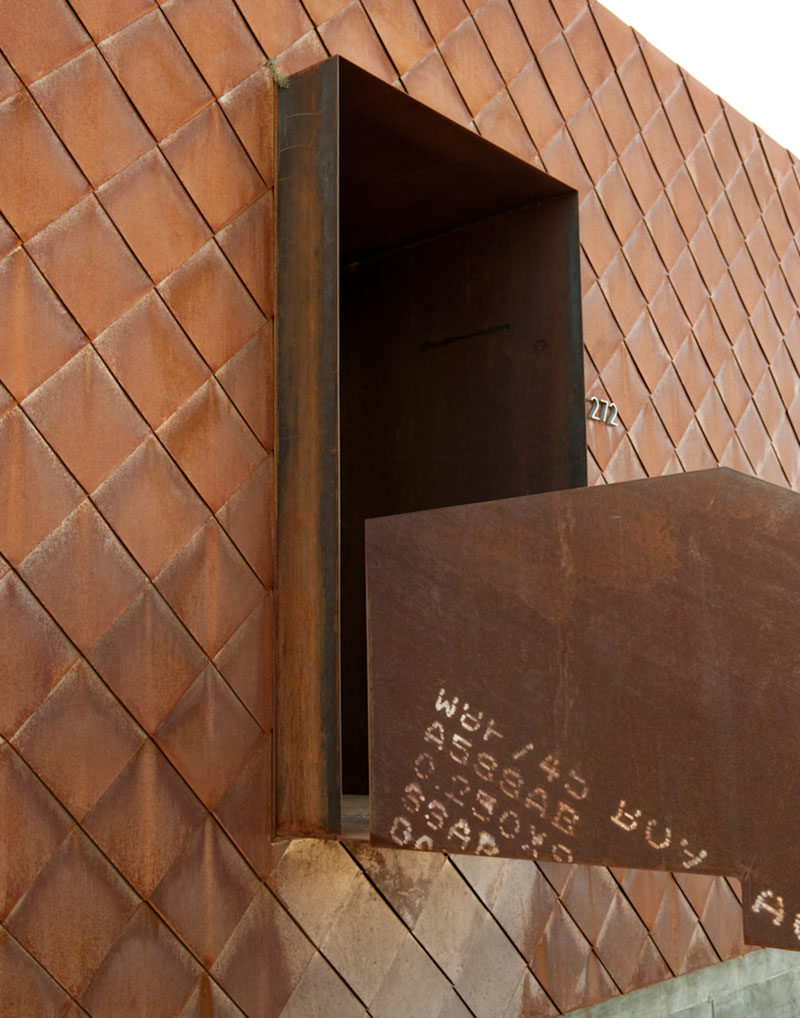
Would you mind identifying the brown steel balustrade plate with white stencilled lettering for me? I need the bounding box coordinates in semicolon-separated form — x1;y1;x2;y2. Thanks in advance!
366;469;800;948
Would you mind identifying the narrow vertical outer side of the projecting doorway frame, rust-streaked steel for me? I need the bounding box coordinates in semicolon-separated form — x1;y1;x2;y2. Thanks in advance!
276;61;341;834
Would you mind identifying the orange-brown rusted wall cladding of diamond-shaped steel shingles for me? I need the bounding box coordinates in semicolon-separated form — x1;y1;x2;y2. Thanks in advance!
0;0;800;1018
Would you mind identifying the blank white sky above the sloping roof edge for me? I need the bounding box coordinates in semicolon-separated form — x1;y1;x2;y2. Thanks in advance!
603;0;800;156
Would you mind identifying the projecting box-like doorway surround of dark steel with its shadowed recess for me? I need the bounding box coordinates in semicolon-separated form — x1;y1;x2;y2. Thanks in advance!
276;57;586;834
